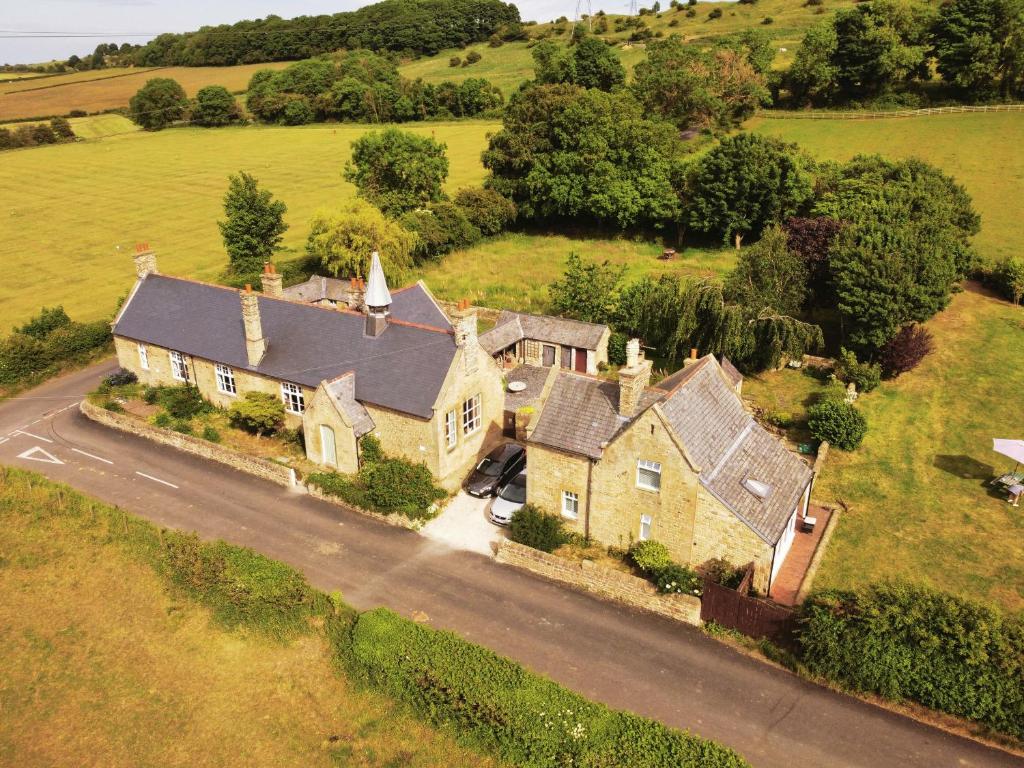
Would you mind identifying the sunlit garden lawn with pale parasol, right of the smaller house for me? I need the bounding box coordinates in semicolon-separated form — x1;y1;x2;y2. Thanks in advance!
798;288;1024;609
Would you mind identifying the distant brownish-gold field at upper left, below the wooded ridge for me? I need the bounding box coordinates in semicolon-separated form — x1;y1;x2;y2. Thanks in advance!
0;61;288;120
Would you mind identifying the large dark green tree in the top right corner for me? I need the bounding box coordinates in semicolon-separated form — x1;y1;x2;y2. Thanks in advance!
932;0;1024;98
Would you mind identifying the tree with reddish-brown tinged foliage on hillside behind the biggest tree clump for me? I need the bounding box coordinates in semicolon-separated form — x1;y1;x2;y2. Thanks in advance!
633;35;771;129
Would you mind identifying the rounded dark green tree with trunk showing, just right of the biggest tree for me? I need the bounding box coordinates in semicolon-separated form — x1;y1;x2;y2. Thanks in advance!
686;133;813;248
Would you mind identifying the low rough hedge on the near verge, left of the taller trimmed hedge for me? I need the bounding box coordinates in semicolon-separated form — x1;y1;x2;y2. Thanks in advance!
161;530;327;639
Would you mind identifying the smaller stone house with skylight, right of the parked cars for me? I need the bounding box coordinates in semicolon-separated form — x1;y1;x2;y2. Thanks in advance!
526;340;813;594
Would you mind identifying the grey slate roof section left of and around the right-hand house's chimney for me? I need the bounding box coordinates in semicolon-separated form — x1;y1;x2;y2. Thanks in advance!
529;372;665;459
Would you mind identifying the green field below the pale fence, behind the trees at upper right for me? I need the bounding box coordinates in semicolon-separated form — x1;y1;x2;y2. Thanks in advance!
748;111;1024;268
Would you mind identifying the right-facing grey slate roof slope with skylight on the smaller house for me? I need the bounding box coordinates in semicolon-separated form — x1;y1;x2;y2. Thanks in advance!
658;355;811;545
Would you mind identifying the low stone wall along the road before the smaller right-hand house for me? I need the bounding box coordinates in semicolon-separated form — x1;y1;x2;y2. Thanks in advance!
497;539;700;627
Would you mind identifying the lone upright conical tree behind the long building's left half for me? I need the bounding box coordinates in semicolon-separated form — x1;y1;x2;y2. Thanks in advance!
217;171;288;275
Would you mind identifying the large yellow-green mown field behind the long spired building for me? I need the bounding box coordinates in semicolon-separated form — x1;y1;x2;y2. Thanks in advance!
0;122;497;330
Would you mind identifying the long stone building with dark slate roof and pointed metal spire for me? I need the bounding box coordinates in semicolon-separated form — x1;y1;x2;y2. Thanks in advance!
113;251;504;490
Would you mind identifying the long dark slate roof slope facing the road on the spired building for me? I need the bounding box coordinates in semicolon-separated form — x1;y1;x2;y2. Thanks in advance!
114;274;456;419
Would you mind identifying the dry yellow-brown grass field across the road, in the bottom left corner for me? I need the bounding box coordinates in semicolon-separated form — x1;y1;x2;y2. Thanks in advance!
0;479;493;768
